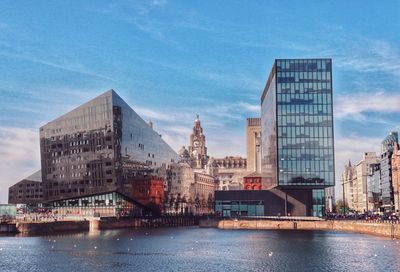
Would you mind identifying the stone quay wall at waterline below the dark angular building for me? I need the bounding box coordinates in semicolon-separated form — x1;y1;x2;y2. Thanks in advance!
16;216;199;235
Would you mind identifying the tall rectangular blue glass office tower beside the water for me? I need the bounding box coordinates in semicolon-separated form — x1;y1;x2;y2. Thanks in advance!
261;59;335;216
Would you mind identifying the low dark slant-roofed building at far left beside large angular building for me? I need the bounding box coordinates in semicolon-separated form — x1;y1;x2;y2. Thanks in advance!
8;170;44;206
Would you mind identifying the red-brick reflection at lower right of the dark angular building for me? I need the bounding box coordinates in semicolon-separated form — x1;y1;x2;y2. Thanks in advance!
132;175;165;211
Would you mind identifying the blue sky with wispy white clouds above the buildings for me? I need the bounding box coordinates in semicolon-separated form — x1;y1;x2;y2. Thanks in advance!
0;0;400;203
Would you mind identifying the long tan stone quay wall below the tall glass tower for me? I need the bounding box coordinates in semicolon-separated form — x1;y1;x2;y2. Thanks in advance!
199;219;400;238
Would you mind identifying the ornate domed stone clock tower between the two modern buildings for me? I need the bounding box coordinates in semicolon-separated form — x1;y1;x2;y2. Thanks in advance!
189;115;208;168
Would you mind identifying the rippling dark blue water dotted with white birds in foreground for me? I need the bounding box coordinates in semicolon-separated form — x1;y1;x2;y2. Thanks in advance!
0;227;400;272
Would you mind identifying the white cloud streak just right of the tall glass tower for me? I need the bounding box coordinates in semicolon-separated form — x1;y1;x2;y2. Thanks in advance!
334;91;400;120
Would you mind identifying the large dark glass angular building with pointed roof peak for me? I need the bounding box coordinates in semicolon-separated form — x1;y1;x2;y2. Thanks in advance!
40;90;179;215
